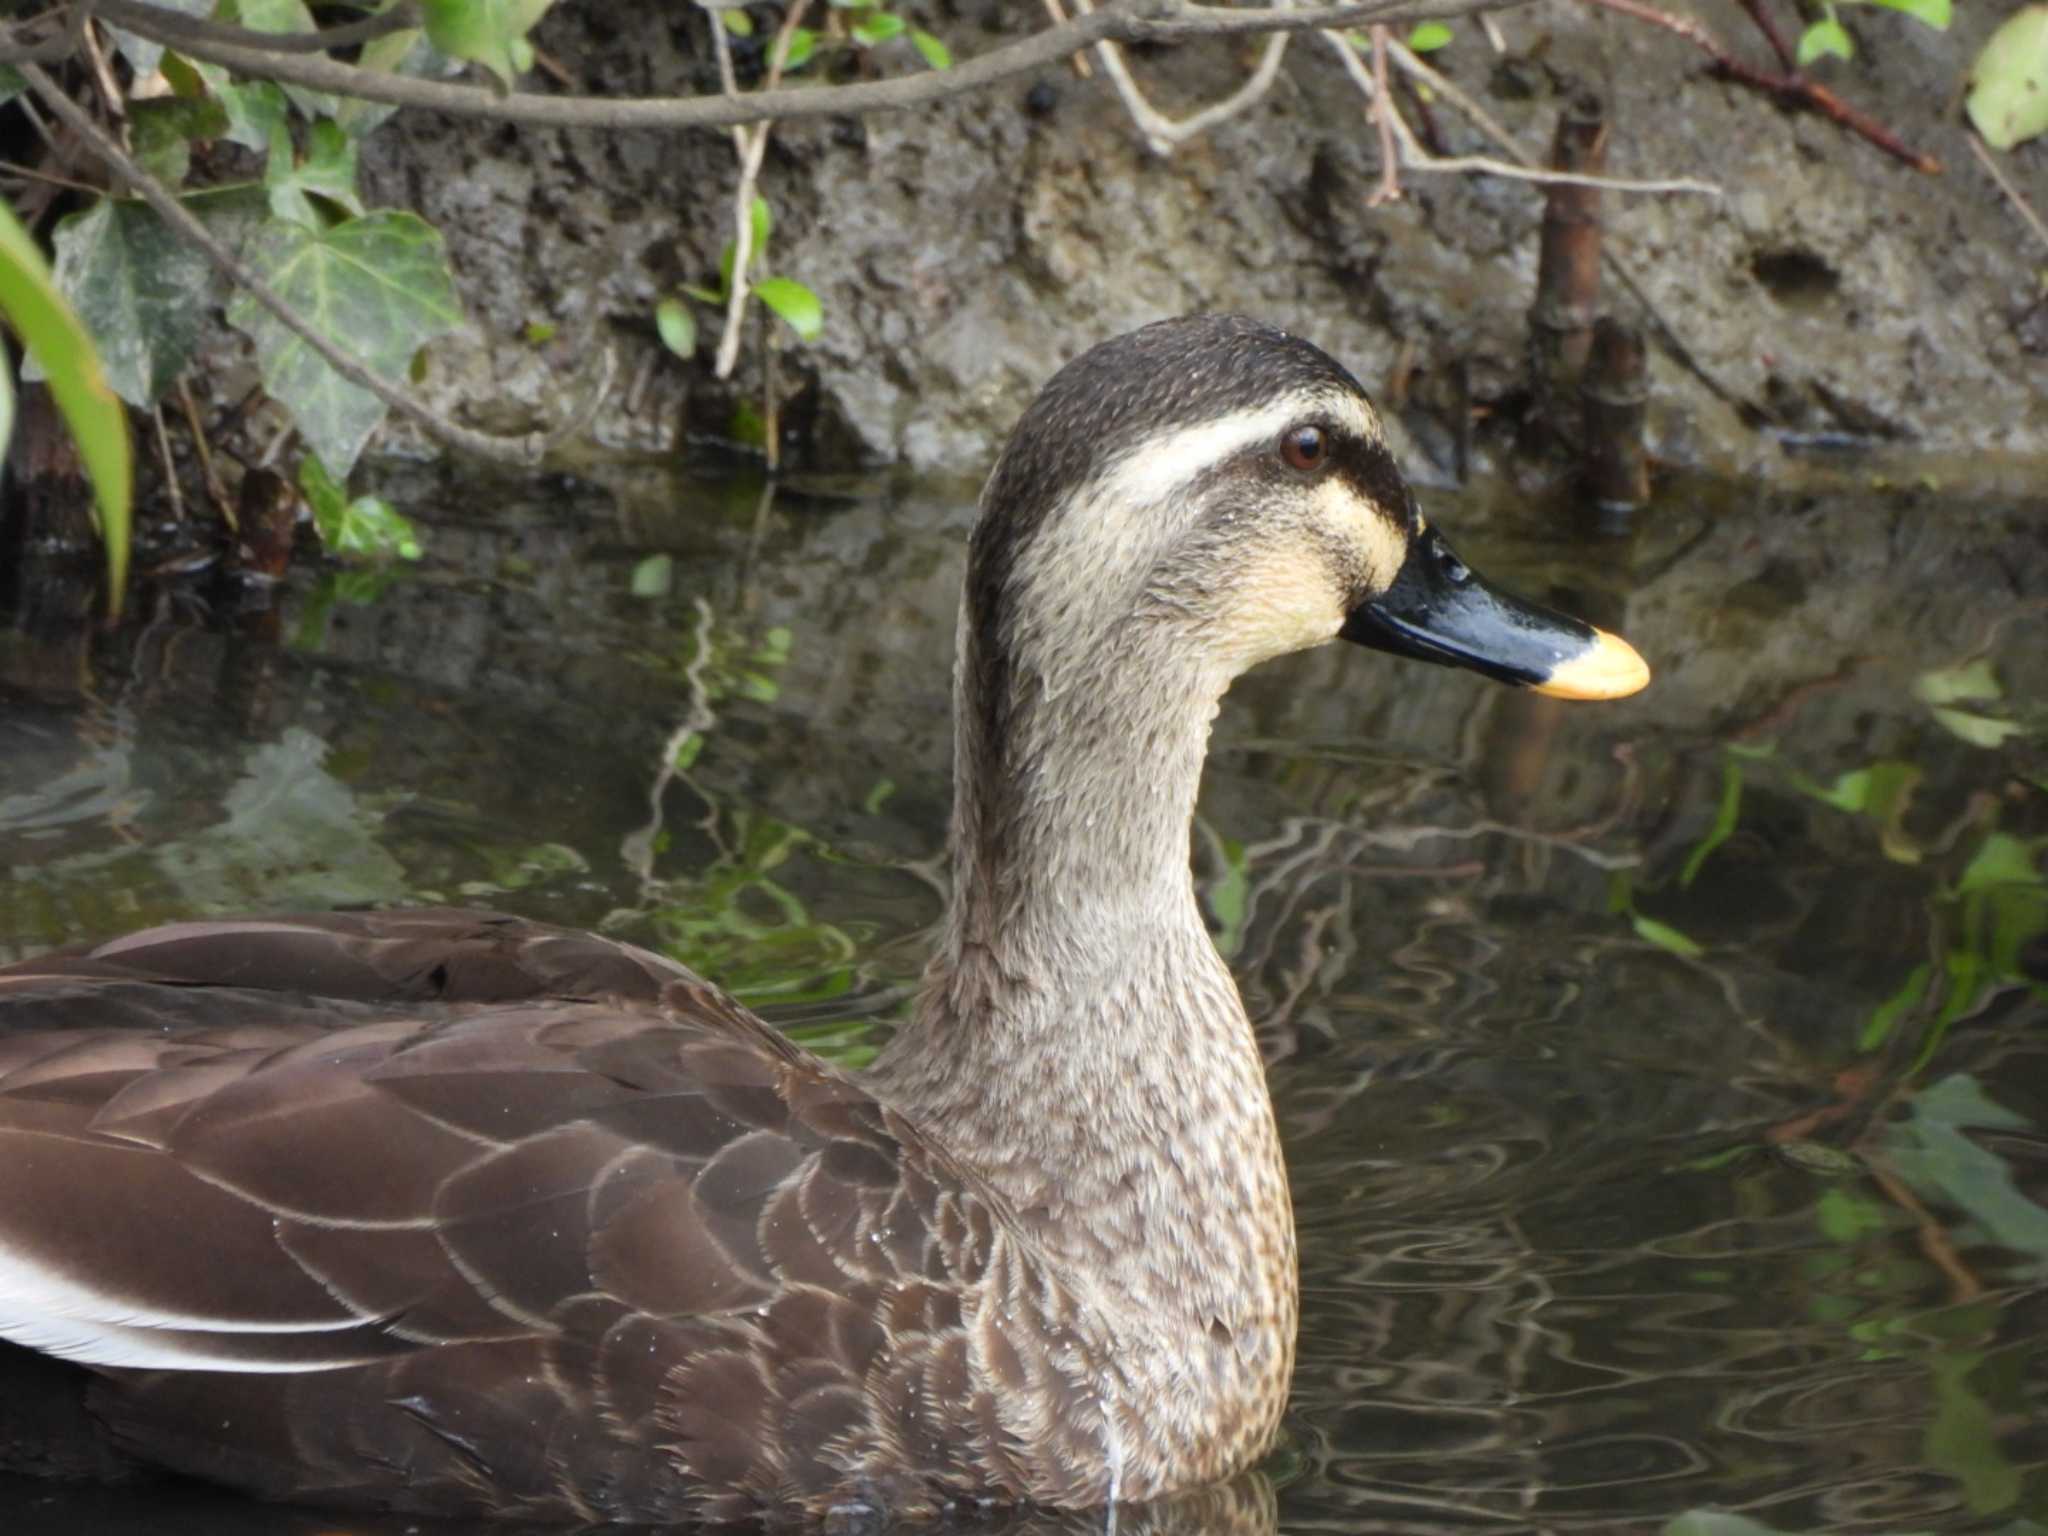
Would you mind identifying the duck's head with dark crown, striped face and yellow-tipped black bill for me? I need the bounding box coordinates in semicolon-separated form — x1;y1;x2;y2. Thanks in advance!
967;315;1649;711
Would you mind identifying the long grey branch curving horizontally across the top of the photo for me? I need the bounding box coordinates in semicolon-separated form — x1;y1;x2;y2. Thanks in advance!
96;0;1522;131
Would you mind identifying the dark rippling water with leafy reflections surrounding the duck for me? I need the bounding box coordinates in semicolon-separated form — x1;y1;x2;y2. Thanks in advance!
0;471;2048;1536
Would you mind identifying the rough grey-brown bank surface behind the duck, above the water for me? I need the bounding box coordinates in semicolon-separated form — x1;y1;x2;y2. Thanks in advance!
356;0;2048;475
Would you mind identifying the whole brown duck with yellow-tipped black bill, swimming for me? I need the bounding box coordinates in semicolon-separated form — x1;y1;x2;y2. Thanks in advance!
0;315;1649;1528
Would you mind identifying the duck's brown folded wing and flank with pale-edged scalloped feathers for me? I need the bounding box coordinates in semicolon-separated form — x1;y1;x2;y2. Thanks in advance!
0;913;1102;1520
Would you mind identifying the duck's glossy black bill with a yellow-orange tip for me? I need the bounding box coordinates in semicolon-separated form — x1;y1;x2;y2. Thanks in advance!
1341;528;1651;698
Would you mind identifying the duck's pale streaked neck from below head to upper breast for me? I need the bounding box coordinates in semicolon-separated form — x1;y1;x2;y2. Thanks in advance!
874;627;1294;1370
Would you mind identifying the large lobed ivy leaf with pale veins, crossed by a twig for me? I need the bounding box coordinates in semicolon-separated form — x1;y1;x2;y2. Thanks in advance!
227;209;463;475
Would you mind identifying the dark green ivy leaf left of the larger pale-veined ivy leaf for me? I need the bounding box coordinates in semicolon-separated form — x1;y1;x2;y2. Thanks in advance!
35;199;213;410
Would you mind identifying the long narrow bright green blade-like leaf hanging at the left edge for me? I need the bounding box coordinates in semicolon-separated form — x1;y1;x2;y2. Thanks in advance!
0;203;133;614
